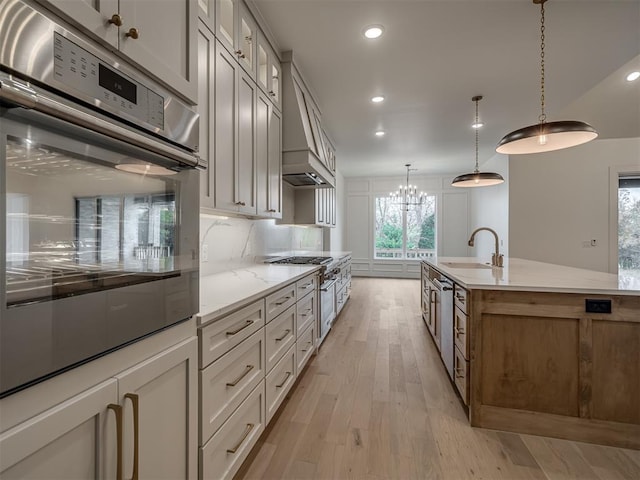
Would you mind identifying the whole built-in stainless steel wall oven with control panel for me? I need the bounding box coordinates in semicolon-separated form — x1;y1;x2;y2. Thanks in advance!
0;0;204;397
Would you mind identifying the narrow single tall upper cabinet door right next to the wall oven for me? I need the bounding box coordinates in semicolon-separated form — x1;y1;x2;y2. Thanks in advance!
198;22;216;208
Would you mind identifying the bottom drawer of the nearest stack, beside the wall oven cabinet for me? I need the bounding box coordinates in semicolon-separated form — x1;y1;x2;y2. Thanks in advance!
200;380;266;480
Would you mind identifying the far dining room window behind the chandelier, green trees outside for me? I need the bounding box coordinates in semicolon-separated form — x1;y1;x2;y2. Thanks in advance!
374;195;436;259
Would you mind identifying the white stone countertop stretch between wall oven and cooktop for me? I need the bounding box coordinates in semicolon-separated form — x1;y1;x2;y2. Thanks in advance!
197;263;320;326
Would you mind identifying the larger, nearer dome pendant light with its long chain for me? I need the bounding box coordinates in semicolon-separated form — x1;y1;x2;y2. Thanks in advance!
496;0;598;155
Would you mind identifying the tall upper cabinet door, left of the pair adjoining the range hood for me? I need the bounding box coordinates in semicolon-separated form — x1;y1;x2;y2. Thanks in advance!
256;93;271;217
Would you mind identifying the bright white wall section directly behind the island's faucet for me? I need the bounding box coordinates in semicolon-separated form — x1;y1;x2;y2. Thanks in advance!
469;154;509;258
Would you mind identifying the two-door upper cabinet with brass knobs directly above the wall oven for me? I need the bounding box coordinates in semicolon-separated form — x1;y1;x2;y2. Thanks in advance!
48;0;198;104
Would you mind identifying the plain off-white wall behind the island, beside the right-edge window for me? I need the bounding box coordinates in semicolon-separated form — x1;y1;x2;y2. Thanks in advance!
509;138;640;272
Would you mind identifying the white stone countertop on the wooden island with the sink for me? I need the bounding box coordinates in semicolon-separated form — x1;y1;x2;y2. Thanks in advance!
424;257;640;295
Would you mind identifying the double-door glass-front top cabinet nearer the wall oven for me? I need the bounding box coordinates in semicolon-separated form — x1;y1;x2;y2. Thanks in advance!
215;0;258;79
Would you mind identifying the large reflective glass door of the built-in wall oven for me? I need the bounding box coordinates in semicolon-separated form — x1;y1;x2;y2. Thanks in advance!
0;102;199;398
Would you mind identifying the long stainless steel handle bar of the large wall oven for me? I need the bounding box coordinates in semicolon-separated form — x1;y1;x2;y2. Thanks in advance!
0;76;207;169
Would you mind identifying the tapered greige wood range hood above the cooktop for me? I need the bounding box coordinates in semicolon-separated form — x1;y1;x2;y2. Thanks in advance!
282;51;336;188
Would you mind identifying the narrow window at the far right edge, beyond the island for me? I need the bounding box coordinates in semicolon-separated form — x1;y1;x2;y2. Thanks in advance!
618;175;640;288
